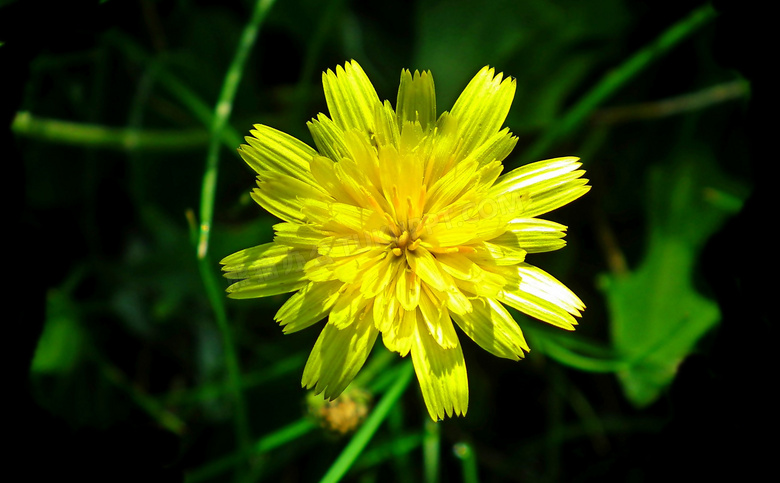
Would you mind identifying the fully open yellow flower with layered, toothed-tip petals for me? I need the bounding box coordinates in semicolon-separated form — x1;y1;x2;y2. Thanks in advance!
222;61;590;420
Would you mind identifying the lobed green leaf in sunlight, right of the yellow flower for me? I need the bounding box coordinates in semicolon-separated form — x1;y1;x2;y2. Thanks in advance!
604;151;744;407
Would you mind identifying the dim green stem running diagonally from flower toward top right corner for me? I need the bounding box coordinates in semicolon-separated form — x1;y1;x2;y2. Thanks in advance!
520;4;716;165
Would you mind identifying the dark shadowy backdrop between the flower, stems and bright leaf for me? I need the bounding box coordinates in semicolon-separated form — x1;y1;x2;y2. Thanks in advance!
6;0;777;481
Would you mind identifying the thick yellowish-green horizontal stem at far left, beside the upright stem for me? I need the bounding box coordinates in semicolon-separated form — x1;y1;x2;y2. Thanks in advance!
11;111;209;151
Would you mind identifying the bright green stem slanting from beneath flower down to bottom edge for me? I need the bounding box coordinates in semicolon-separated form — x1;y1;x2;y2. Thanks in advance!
320;361;414;483
